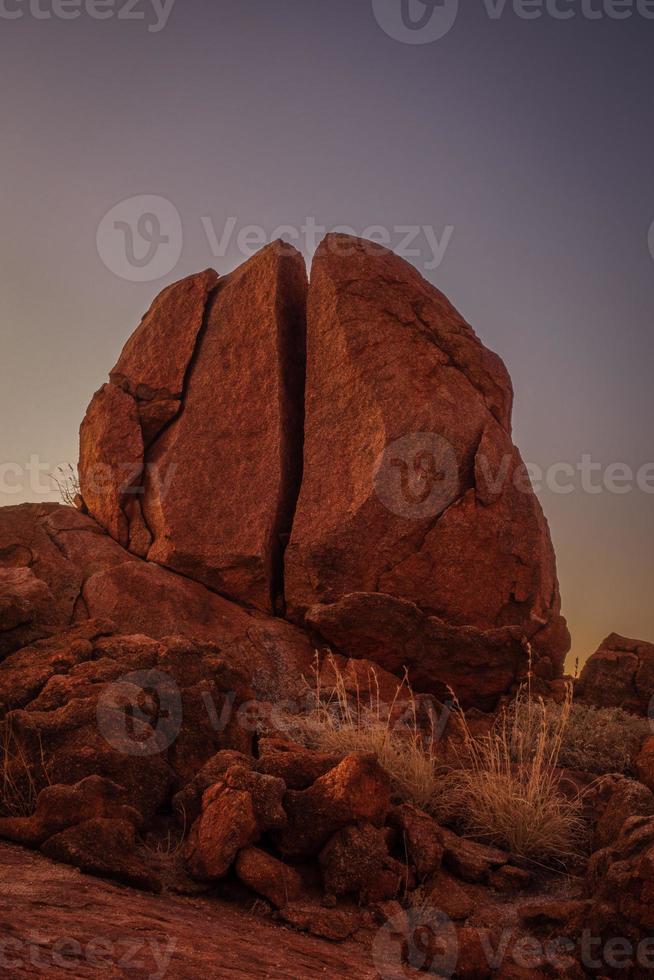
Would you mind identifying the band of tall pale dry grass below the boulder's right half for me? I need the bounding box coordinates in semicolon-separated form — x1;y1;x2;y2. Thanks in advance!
276;658;585;866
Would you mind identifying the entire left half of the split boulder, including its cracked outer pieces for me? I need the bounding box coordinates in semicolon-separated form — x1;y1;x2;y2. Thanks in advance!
79;242;307;612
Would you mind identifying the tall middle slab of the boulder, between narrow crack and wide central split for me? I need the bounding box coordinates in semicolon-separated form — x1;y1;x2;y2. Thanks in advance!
144;243;306;611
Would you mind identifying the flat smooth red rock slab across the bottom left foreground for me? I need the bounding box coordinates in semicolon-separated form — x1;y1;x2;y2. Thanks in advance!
0;844;379;980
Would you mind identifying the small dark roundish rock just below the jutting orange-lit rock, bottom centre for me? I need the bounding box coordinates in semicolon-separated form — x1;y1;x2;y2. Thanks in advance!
320;824;388;895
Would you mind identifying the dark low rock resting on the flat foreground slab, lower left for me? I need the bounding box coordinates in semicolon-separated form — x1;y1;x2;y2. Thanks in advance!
41;818;161;892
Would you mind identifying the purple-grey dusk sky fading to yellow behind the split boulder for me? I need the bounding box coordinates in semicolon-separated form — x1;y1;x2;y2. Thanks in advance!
0;0;654;659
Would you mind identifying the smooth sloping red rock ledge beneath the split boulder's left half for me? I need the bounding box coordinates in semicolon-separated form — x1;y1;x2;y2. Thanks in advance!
0;504;326;708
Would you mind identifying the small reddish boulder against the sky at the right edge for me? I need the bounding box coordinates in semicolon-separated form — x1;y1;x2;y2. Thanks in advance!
575;633;654;716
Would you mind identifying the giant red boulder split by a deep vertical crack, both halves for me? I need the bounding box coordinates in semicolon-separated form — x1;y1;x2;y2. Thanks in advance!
75;235;569;709
